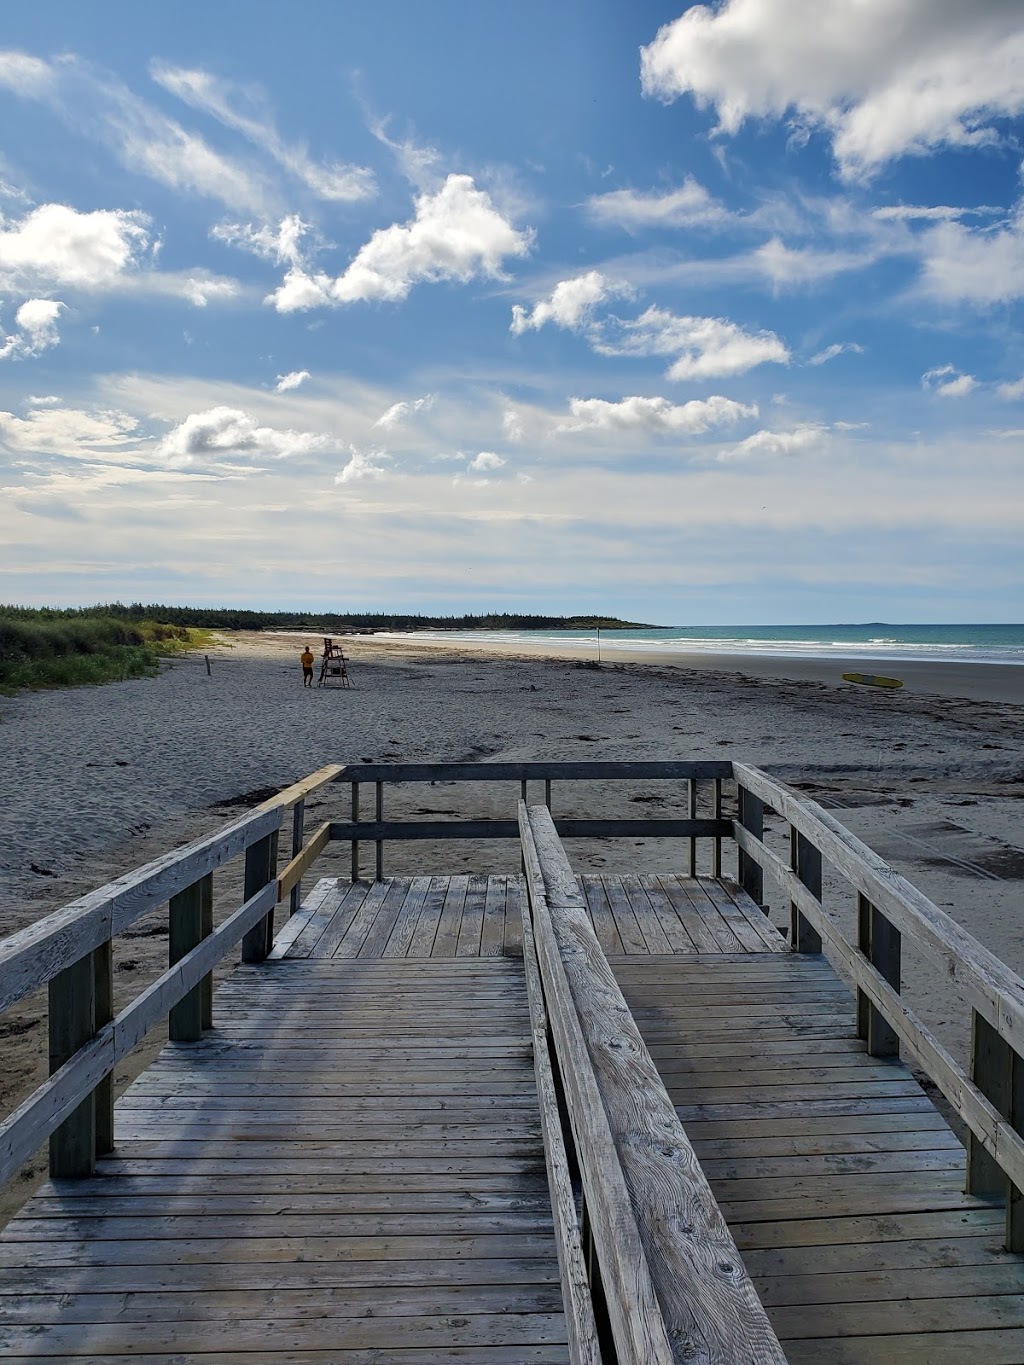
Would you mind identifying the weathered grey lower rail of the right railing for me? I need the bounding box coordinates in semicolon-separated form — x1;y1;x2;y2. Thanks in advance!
736;826;1024;1188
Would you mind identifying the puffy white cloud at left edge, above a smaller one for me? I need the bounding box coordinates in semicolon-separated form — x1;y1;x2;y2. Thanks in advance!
0;203;149;289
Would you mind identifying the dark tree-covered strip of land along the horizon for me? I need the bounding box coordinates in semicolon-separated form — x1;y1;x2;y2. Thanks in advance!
8;602;658;635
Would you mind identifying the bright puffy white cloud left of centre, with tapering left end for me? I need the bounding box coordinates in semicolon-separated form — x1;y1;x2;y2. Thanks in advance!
268;175;532;313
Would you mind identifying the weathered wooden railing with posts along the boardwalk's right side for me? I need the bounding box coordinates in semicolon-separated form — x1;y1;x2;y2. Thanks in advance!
733;763;1024;1252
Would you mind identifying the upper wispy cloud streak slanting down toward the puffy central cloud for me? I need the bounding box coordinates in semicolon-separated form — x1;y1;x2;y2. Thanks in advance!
150;61;377;203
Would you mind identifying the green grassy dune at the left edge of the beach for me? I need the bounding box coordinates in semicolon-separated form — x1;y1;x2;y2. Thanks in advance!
0;606;209;695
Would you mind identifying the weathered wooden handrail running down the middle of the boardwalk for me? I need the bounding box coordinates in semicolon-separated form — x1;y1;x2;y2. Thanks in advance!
519;803;785;1365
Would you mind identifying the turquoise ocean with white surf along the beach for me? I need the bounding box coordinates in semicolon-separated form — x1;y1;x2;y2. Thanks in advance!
388;621;1024;665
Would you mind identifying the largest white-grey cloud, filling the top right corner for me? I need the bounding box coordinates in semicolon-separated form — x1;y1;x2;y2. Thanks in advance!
640;0;1024;176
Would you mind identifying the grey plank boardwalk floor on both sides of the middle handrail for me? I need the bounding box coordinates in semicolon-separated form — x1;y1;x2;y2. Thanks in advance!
0;875;1024;1365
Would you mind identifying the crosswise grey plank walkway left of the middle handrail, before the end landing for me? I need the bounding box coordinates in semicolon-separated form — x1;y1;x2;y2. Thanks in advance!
0;958;568;1365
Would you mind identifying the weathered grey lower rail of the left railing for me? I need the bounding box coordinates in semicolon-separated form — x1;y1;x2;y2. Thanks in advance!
0;882;277;1183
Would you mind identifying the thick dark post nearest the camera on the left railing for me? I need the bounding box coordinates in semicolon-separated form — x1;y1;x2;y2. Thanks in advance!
48;953;96;1179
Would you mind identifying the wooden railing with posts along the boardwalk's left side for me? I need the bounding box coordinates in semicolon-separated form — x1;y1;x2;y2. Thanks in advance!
0;764;341;1183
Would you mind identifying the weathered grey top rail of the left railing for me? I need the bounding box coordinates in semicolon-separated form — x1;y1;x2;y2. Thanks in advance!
0;807;281;1010
